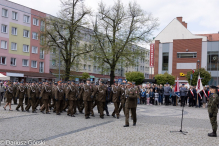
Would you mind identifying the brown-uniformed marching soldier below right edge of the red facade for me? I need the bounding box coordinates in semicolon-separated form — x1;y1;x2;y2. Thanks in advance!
40;81;52;114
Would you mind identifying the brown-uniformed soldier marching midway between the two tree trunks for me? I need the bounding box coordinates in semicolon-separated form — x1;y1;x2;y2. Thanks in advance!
80;79;94;119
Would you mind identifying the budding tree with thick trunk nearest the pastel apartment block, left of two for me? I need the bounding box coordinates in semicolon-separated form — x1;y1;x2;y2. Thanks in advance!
41;0;93;80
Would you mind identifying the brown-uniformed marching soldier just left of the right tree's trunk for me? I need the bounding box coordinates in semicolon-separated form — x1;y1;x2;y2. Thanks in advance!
96;81;106;119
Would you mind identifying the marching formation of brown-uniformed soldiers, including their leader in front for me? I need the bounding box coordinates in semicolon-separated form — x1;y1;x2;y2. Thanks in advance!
3;79;140;127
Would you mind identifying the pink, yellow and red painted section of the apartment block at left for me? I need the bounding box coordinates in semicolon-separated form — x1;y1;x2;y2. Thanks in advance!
0;0;54;81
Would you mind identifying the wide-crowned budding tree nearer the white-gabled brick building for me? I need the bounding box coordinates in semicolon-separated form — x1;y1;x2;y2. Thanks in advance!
93;0;159;84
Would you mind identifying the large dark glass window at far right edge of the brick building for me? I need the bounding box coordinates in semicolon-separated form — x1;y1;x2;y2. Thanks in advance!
207;51;219;71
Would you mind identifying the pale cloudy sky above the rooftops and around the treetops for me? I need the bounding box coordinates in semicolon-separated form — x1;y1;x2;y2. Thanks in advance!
8;0;219;48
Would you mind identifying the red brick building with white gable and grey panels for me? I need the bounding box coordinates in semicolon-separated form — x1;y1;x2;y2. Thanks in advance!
152;17;219;85
